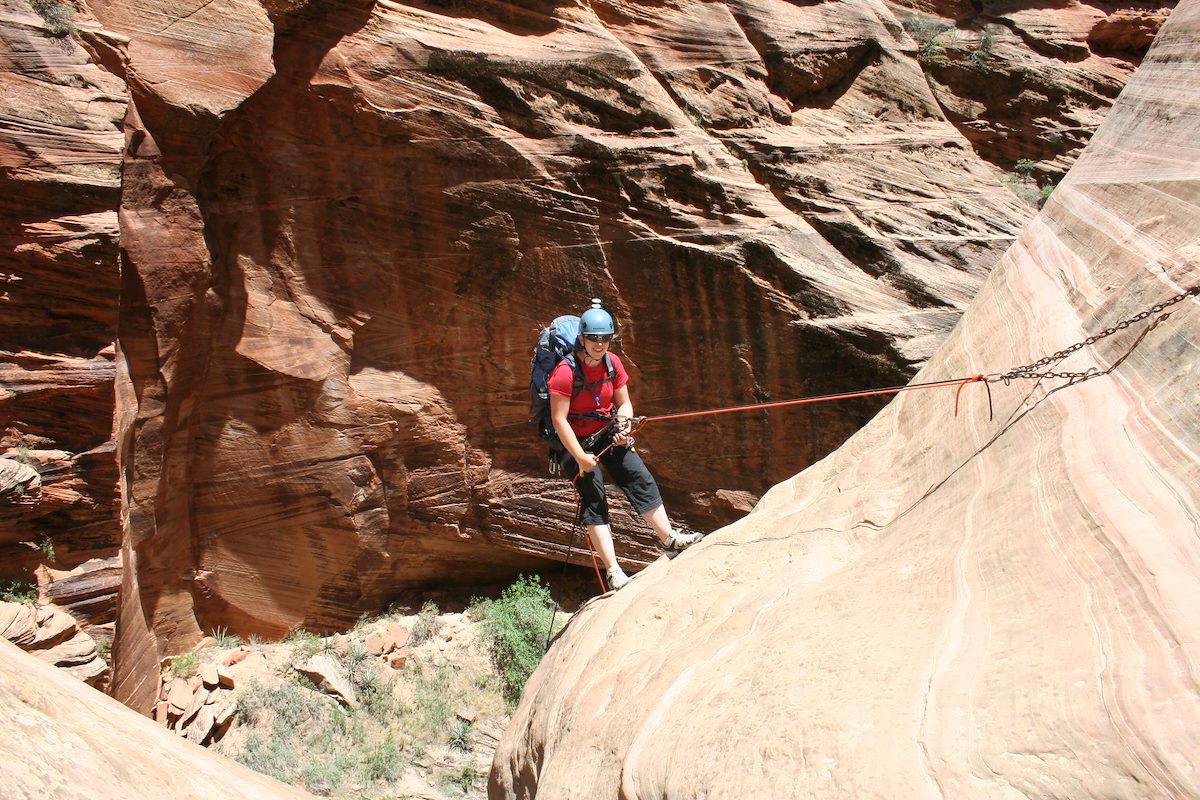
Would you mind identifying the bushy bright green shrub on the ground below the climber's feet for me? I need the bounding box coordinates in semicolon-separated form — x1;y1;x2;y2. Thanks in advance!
468;576;557;704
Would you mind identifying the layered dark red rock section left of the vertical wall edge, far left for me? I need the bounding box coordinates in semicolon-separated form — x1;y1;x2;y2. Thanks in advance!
0;0;126;624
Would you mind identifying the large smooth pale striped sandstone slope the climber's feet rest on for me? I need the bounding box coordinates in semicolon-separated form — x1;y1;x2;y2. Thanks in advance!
490;6;1200;800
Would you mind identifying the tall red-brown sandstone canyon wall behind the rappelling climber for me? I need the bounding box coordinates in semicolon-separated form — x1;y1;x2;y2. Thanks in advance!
0;0;1170;706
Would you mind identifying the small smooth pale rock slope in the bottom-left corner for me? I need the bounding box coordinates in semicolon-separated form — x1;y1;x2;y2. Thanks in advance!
0;642;312;800
